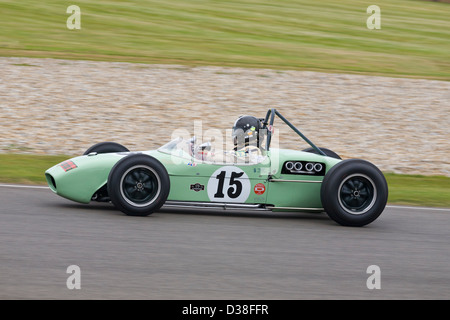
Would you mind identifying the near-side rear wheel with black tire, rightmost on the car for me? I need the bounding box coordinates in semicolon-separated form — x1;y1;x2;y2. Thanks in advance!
320;159;388;227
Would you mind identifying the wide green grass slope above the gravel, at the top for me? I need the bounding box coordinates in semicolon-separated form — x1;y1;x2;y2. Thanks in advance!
0;0;450;80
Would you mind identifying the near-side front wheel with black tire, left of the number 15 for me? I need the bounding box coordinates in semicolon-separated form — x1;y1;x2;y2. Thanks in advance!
107;154;170;216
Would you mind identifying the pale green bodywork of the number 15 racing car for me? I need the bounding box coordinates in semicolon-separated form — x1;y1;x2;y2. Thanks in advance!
45;149;341;208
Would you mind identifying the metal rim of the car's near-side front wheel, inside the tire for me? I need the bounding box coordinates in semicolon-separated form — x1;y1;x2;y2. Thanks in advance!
120;165;161;207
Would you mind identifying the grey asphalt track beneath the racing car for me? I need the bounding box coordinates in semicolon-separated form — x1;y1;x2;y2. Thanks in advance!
0;186;450;300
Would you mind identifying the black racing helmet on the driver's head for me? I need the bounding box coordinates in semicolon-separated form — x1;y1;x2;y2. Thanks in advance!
231;116;262;149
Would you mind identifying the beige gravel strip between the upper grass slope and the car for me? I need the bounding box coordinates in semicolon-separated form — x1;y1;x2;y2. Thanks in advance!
0;58;450;176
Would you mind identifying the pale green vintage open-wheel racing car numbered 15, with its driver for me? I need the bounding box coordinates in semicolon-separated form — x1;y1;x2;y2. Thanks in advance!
45;109;388;226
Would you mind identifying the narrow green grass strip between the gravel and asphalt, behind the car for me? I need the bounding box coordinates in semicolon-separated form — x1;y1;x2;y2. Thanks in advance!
0;154;450;208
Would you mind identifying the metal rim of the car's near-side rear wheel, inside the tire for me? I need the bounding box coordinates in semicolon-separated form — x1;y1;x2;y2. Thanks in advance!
338;174;377;215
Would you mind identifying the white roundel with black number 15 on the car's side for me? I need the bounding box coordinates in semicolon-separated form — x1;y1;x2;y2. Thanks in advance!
207;166;251;203
